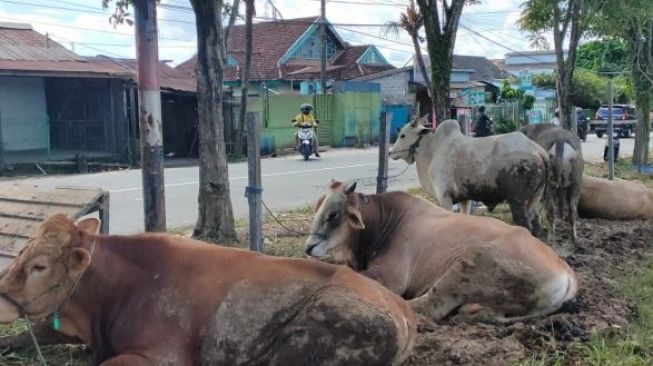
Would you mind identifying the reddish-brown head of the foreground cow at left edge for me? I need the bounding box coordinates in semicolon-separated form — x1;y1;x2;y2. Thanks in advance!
0;215;99;323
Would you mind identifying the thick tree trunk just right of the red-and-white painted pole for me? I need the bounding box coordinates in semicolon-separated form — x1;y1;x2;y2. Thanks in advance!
191;0;236;240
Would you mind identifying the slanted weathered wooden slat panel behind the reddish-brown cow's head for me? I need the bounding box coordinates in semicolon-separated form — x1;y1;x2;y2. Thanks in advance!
0;185;109;268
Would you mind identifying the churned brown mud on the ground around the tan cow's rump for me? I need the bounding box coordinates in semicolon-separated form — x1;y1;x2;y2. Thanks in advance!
404;220;653;366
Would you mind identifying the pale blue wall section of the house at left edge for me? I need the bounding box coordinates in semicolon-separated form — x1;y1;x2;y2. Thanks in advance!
0;77;49;151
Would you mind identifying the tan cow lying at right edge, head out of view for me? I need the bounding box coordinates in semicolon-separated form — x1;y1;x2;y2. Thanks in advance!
578;175;653;220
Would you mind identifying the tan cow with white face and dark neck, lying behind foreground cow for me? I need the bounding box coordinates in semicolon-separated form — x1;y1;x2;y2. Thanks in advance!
306;181;577;321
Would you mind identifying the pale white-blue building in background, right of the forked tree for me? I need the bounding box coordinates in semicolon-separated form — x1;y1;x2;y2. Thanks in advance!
493;50;569;77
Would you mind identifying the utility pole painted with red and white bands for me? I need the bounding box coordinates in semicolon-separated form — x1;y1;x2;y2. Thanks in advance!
134;0;166;231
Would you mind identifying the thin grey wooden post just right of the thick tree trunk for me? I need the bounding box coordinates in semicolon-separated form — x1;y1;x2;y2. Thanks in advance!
245;112;264;252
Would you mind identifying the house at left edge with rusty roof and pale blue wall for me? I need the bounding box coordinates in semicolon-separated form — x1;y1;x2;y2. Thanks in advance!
0;23;130;164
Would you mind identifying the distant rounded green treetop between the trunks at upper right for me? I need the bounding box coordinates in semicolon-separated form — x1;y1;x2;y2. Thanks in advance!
576;38;628;72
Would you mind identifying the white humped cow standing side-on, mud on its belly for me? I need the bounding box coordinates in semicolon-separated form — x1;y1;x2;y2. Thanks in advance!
390;119;550;235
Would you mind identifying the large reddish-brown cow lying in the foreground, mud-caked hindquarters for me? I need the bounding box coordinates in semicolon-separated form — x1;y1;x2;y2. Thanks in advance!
0;215;416;366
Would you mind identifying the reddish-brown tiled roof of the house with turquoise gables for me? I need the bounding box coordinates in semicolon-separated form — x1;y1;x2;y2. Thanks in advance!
177;17;394;81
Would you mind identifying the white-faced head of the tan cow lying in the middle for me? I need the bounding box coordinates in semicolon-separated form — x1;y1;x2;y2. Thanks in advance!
306;180;365;262
